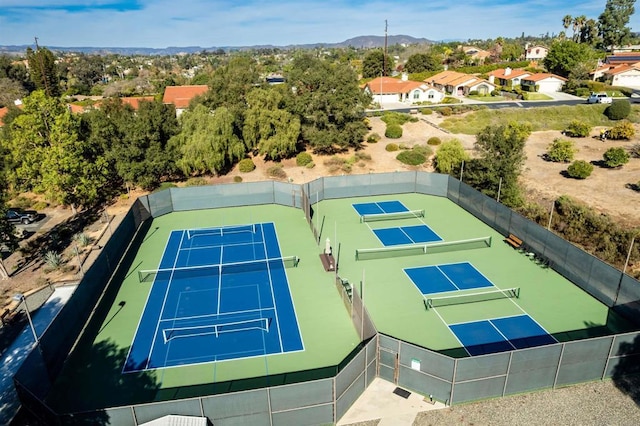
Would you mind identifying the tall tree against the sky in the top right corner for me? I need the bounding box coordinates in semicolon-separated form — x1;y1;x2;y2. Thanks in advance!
598;0;636;49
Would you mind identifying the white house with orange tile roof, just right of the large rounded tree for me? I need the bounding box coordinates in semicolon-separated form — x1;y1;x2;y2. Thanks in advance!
364;75;445;106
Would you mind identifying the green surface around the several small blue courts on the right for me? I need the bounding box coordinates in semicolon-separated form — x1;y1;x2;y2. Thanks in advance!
314;194;633;356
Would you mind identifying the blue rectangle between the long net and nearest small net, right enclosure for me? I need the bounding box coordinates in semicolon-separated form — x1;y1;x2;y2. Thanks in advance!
404;262;493;294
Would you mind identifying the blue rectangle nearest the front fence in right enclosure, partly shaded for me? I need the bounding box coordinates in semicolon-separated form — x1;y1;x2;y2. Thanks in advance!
449;314;557;356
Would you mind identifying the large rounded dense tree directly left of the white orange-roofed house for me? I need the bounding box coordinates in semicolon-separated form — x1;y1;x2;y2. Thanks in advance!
285;55;371;153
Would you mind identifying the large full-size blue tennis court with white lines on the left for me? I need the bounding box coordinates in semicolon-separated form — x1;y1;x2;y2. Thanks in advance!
123;223;303;372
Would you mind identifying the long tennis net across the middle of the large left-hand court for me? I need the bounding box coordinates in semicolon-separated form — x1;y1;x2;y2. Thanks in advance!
138;256;300;283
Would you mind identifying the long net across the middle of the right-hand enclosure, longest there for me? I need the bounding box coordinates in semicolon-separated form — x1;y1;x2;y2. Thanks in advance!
356;236;491;260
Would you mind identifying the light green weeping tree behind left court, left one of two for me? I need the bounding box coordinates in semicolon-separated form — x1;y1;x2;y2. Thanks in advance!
171;105;245;176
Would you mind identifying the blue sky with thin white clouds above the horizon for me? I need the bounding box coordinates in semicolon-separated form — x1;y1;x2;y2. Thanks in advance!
0;0;640;48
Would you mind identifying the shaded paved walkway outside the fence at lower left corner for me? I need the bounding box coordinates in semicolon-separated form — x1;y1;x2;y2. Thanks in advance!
0;286;76;425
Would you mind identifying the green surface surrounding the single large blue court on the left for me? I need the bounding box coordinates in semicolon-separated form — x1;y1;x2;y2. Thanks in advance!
50;205;360;411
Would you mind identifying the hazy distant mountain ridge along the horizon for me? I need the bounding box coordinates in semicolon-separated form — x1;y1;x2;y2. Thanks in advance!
0;35;433;56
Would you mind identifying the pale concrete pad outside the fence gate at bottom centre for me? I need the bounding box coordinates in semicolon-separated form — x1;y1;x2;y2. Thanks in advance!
337;377;446;426
